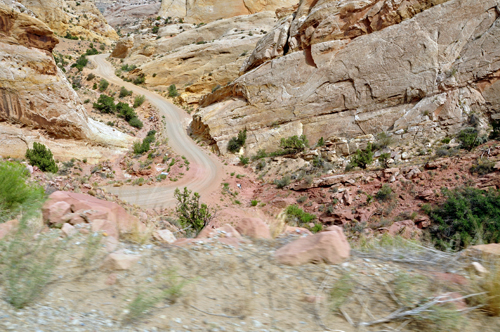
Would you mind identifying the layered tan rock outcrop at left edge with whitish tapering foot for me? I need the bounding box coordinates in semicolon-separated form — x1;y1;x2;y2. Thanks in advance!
0;5;132;160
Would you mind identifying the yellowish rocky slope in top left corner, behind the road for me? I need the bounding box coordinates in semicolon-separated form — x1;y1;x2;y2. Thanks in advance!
3;0;118;42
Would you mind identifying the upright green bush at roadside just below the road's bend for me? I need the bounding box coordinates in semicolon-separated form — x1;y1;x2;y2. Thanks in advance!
174;187;214;235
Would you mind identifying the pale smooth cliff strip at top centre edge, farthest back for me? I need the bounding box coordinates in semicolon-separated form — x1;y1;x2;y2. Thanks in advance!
159;0;298;23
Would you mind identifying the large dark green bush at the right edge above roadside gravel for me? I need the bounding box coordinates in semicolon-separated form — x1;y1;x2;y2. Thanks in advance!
430;187;500;249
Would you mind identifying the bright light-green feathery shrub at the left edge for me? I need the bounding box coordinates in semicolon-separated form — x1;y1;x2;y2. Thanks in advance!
0;162;45;222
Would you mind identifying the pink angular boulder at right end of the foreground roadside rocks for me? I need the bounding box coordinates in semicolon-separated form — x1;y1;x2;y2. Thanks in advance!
274;226;351;266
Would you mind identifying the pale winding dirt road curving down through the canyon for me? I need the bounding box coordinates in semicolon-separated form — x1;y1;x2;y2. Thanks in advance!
89;54;223;208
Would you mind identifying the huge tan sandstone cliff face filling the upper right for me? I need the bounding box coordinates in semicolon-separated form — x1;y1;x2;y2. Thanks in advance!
192;0;500;153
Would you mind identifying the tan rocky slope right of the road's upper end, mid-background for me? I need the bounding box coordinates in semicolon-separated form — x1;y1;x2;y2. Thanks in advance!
112;12;276;103
